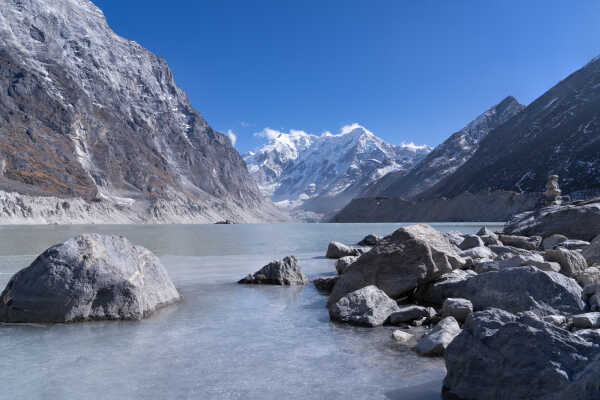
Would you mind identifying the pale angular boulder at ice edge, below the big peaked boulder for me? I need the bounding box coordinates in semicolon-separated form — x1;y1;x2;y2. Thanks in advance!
328;285;400;326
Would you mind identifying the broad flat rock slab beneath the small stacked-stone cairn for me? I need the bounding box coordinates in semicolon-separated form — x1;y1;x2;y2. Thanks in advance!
504;198;600;242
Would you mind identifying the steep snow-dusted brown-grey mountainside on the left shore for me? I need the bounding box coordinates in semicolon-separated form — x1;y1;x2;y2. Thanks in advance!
0;0;280;222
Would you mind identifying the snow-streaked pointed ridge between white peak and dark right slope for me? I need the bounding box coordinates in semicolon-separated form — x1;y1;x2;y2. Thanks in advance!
361;96;525;198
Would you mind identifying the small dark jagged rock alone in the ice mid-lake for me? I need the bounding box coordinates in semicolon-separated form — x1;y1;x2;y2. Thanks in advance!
238;256;308;286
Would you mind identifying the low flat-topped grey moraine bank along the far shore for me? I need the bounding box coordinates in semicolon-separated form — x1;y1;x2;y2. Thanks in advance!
331;191;540;222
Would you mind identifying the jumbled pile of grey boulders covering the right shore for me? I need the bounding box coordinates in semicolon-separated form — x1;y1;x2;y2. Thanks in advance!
314;209;600;400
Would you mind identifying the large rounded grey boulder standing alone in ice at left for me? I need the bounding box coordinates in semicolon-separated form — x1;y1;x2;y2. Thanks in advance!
0;234;181;322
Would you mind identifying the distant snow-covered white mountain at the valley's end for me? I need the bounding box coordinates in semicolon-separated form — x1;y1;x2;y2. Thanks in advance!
244;124;431;219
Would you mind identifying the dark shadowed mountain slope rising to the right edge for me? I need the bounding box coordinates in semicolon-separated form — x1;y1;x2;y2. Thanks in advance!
425;57;600;197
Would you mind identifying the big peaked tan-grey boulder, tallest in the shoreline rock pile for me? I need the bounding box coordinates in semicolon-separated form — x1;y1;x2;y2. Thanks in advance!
328;225;465;304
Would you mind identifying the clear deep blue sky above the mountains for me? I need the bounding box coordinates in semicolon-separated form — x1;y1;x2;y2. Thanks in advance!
94;0;600;152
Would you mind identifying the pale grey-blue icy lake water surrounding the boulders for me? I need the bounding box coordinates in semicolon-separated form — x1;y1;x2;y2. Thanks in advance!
0;224;502;400
